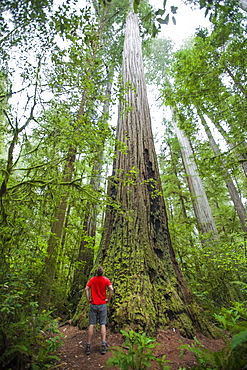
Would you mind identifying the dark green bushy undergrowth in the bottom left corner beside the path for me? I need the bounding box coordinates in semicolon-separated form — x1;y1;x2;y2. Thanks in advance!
0;275;62;369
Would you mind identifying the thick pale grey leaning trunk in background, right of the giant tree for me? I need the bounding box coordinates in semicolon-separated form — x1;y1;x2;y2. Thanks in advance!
173;113;218;239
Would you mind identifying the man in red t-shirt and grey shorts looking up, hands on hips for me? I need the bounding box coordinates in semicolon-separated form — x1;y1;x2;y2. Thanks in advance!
85;266;113;355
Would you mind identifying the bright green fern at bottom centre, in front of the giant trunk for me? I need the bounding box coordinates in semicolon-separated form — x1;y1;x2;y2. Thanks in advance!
107;330;170;370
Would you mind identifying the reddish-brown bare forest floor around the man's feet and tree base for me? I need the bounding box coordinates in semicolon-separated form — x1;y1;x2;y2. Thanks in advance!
52;325;224;370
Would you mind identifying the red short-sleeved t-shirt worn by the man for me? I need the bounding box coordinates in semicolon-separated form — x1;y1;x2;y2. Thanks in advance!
87;276;112;304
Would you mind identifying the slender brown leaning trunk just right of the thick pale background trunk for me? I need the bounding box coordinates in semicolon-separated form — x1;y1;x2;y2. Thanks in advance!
198;111;247;233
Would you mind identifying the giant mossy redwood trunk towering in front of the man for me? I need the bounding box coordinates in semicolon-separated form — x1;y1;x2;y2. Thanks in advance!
74;12;215;337
